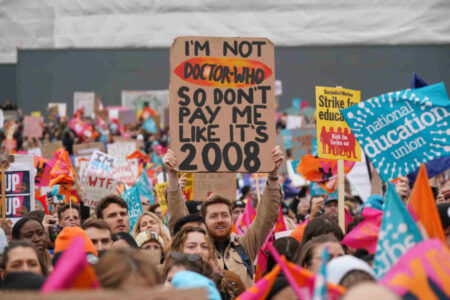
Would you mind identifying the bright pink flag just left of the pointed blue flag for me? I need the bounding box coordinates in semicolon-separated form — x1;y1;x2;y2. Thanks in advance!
341;207;383;254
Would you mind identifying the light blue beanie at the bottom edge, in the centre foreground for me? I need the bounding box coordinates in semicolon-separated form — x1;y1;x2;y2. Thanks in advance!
171;271;222;300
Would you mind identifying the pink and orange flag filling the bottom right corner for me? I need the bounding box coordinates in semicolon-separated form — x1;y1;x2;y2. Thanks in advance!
380;239;450;299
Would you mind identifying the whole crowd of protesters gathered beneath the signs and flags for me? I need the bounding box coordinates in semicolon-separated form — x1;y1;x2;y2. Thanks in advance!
0;99;450;300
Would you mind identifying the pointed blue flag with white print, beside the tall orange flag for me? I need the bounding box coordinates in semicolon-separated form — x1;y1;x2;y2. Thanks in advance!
373;182;422;279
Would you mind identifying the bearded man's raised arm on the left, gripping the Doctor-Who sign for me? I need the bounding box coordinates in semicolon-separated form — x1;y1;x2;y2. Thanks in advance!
163;149;189;234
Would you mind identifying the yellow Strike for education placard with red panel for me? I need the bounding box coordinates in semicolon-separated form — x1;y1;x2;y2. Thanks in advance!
316;86;361;161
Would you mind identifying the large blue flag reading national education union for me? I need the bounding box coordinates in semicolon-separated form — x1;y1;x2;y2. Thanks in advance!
342;83;450;182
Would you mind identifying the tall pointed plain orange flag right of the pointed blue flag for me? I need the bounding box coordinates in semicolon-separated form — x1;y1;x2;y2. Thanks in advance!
408;164;446;244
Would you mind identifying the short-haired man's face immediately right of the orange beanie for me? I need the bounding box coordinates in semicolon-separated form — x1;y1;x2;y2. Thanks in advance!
81;217;113;256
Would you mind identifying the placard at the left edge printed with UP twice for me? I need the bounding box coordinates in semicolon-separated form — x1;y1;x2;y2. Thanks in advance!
0;162;34;223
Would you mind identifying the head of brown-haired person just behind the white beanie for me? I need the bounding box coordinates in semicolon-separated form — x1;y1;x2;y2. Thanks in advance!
298;234;345;273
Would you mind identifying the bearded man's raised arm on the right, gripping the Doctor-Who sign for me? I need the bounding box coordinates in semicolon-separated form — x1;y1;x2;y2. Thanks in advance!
240;146;284;261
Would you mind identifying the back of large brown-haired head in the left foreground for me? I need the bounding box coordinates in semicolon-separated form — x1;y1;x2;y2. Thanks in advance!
94;248;162;289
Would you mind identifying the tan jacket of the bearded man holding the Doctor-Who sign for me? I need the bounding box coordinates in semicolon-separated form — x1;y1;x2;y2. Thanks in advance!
167;180;282;288
